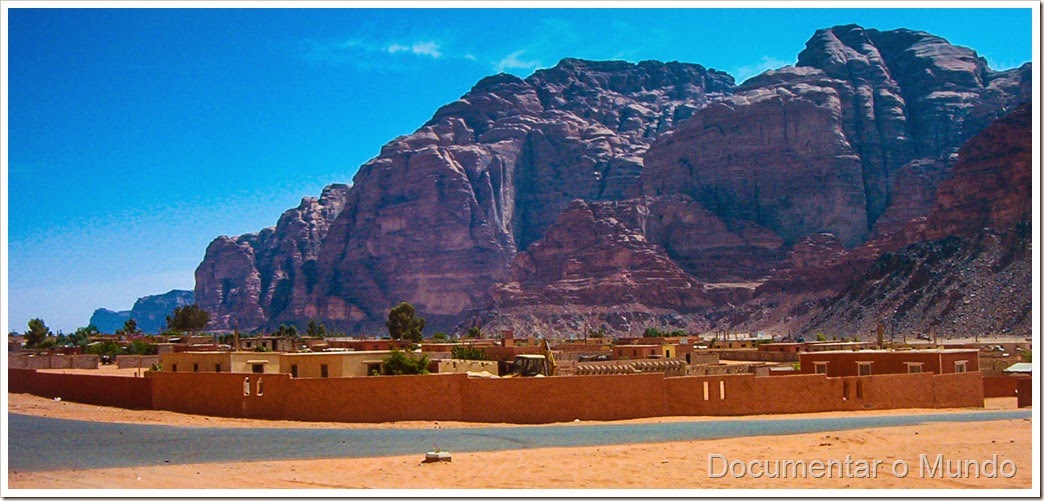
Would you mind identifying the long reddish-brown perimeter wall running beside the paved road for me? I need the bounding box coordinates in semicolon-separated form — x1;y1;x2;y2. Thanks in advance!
8;369;983;424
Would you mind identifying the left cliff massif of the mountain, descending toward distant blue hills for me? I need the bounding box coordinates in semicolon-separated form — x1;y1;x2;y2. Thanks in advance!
197;59;733;329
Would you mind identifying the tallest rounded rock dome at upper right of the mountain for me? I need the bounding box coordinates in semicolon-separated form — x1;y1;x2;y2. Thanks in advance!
643;26;1029;247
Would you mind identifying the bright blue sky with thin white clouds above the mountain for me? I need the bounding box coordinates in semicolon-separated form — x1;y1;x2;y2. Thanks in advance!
4;8;1033;332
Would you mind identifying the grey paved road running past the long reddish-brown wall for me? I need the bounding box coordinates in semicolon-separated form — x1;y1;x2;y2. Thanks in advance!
7;410;1031;471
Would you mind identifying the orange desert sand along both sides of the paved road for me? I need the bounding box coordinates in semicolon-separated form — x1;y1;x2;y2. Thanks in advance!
7;393;1034;490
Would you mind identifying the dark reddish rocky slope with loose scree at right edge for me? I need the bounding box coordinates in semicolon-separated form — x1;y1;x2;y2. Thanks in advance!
743;103;1033;337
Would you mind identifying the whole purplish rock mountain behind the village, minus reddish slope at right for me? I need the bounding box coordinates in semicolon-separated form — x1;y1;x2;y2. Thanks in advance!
195;26;1031;331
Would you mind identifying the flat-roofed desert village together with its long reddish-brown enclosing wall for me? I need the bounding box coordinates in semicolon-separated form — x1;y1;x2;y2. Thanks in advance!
8;331;1031;424
